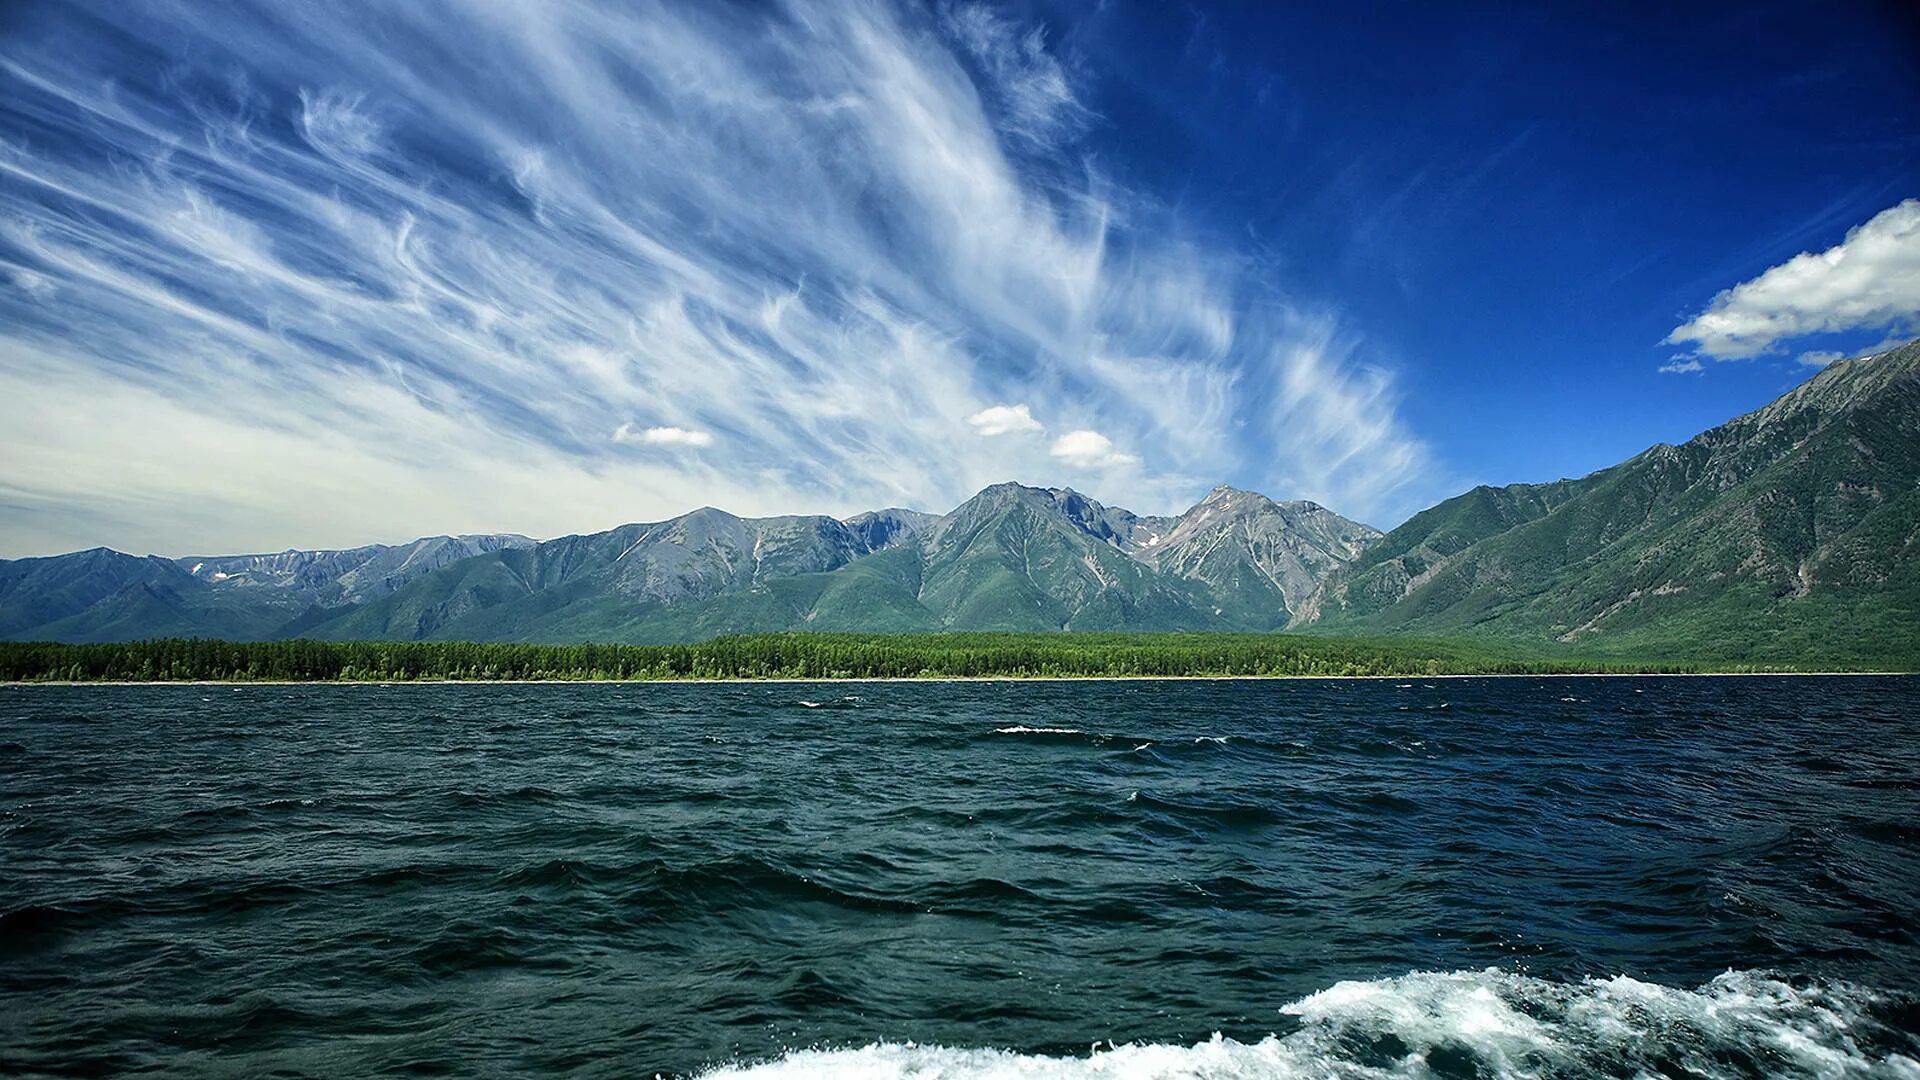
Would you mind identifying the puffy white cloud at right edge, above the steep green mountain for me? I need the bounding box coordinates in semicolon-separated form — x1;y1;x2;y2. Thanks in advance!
1667;198;1920;359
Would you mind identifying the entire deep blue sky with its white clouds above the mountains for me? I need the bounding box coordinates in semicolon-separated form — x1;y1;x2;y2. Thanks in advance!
0;0;1920;557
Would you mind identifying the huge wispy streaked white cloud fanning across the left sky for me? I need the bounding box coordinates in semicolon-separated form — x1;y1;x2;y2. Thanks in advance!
0;0;1427;553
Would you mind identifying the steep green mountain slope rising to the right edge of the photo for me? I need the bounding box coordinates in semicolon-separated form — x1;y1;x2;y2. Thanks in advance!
1300;342;1920;663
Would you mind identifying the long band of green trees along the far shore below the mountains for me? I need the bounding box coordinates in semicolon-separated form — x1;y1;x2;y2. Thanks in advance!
0;634;1766;682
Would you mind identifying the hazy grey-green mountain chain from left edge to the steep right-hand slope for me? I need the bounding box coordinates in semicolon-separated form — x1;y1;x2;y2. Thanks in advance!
0;484;1379;642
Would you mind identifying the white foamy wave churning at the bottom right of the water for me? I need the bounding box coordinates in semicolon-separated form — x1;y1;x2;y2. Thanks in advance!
703;969;1920;1080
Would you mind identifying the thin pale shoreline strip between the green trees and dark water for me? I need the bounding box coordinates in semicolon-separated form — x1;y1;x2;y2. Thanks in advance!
0;671;1920;688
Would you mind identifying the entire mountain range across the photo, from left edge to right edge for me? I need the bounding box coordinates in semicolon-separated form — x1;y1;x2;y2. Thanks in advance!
0;342;1920;667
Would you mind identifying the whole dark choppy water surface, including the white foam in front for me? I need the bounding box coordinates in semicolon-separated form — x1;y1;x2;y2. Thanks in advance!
0;678;1920;1076
